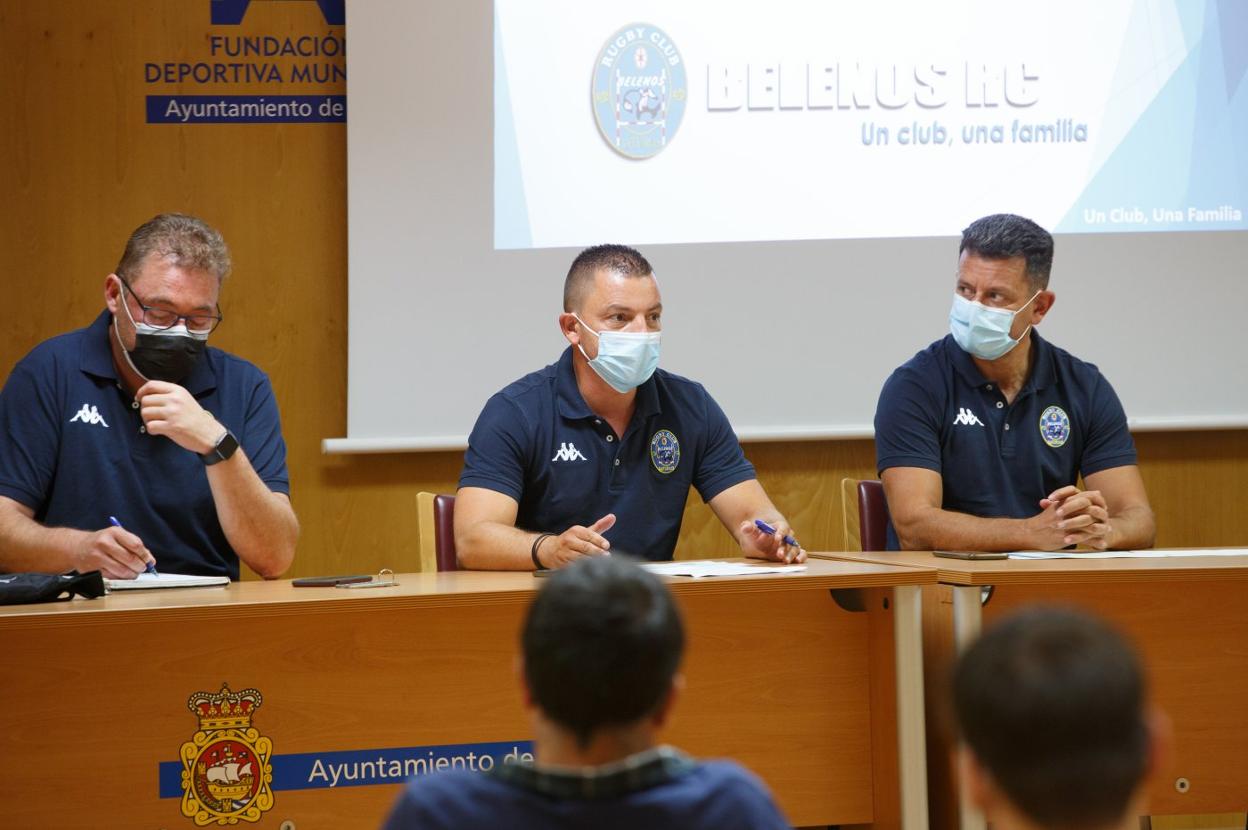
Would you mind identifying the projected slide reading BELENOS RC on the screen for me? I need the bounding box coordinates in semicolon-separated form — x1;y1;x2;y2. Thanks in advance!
494;0;1248;248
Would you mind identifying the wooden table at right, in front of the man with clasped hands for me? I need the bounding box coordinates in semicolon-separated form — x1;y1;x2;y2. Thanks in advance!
814;550;1248;829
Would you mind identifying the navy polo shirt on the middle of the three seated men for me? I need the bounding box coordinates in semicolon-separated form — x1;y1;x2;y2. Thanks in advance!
459;347;754;560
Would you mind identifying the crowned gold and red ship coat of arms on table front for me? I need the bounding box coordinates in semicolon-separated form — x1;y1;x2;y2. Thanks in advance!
180;684;273;826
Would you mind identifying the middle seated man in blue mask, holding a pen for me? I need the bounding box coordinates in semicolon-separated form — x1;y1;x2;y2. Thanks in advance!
454;245;805;570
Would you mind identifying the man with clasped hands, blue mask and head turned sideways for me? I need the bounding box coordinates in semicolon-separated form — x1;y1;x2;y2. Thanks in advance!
875;213;1154;550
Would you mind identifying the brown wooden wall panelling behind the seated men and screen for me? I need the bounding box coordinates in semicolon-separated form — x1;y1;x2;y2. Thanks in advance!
0;0;1248;575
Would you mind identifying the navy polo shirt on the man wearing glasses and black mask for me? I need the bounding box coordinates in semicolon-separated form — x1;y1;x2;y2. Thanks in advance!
0;311;290;579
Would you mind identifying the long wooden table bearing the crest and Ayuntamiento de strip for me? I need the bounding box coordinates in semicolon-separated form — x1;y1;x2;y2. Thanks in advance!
0;562;936;830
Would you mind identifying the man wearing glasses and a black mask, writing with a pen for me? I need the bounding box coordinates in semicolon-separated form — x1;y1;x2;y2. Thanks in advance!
0;213;298;579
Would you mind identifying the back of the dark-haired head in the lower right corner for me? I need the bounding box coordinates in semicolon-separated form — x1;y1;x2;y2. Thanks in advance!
952;608;1149;829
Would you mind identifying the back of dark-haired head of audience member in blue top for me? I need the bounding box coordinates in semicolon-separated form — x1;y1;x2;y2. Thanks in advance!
522;557;685;745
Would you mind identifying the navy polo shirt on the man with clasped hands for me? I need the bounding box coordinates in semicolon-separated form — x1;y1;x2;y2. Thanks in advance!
875;330;1136;550
